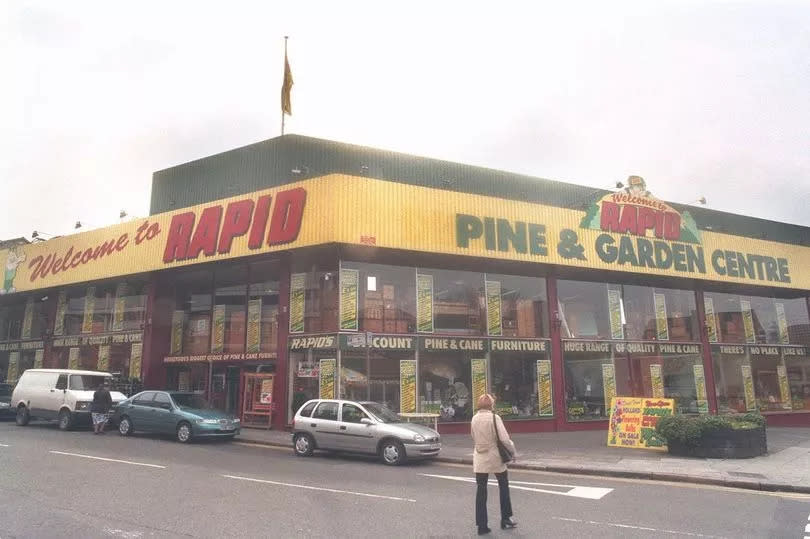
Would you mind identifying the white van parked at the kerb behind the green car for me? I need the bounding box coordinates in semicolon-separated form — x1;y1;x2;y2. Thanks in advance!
11;369;126;430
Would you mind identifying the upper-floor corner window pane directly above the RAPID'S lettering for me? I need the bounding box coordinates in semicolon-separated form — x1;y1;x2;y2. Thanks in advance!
290;260;339;333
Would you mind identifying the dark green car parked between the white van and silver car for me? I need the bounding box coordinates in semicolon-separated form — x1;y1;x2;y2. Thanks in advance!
111;391;241;443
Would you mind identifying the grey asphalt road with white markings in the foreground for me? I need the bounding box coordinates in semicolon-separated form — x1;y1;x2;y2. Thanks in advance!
0;422;810;539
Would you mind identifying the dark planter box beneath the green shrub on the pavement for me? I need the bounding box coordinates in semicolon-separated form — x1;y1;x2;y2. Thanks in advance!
667;426;768;459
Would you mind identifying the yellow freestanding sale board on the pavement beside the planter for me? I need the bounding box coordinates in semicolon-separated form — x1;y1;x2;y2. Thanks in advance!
608;397;675;451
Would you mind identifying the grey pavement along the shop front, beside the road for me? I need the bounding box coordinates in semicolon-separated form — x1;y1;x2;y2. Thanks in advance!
239;427;810;493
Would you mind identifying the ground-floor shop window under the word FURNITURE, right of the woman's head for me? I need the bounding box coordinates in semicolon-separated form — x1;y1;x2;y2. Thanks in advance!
490;352;553;419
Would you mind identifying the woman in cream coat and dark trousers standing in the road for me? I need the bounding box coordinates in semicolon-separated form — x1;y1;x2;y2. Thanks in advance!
470;395;517;535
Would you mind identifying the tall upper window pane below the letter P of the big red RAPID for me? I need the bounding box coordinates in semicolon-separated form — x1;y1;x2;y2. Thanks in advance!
211;265;247;354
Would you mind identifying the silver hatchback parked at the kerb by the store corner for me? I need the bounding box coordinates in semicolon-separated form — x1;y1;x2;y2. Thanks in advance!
292;399;442;466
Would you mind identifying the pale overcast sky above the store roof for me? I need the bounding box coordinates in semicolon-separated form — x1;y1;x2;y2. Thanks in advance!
0;0;810;239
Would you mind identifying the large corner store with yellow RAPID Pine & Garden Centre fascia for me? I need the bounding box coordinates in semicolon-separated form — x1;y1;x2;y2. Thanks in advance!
0;135;810;432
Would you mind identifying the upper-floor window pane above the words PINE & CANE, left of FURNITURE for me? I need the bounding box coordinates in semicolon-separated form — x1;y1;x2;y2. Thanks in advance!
417;269;485;335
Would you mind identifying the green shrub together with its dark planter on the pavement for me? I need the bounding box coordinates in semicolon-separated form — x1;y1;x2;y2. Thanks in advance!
655;413;768;458
